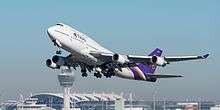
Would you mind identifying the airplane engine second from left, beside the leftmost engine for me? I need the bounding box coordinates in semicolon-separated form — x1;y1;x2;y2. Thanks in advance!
52;55;67;66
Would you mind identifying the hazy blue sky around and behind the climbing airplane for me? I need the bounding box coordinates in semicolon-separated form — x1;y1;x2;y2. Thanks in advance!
0;0;220;101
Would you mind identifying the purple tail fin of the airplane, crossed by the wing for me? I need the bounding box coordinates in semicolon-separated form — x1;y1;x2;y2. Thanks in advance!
138;48;163;74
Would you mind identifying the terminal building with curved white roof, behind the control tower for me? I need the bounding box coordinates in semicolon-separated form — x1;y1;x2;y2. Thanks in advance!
31;93;121;110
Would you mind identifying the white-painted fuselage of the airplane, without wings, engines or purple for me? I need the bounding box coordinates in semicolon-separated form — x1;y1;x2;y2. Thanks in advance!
47;24;155;80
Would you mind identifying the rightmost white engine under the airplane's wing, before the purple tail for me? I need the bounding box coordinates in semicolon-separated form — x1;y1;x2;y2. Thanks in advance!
151;56;167;66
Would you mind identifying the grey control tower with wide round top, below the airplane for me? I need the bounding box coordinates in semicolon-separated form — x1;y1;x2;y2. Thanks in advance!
58;69;75;110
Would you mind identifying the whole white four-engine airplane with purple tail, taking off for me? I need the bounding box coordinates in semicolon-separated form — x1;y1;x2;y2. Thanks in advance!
46;23;209;82
